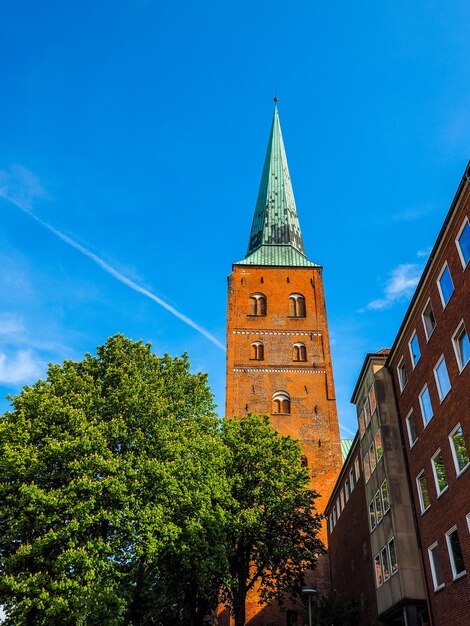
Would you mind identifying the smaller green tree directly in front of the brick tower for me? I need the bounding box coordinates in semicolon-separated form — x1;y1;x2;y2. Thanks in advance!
222;414;324;626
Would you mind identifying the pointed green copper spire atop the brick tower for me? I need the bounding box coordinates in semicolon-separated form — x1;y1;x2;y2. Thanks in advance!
237;106;316;267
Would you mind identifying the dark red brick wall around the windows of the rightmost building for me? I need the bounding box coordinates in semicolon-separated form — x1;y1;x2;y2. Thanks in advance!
390;176;470;626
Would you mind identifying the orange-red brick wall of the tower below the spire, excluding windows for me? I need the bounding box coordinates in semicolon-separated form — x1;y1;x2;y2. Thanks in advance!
226;265;341;626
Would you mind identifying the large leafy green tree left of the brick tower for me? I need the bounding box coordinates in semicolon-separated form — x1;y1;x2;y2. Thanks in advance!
0;335;227;626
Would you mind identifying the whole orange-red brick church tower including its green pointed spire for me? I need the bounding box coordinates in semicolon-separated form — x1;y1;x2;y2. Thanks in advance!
226;107;341;626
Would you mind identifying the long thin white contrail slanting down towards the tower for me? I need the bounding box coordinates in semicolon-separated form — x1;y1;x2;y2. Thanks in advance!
15;202;225;351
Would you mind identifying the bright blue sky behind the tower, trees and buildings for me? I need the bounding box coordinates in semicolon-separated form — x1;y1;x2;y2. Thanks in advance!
0;0;470;437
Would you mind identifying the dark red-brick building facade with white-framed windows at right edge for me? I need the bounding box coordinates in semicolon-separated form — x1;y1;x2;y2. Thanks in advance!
389;165;470;626
